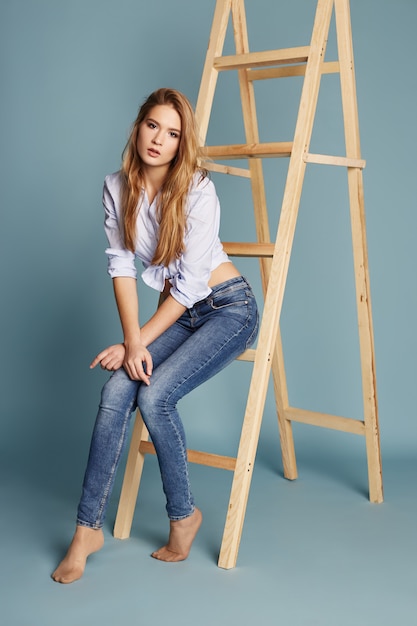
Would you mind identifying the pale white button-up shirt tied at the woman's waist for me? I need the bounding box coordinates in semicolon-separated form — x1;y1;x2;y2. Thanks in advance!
103;172;230;308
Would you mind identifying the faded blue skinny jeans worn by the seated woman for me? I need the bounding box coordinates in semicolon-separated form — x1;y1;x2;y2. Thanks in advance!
77;276;258;529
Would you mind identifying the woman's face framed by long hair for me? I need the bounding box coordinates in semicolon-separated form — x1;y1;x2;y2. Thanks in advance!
136;104;181;170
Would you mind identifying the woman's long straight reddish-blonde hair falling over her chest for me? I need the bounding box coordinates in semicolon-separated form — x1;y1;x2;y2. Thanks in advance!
121;88;206;266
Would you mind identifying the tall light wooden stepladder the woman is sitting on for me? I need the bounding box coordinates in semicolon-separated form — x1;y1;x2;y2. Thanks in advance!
114;0;383;569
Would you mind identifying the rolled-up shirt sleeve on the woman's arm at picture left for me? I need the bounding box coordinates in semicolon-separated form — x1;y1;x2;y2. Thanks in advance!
103;173;137;278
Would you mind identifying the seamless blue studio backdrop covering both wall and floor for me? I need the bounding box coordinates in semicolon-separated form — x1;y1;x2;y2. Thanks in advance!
0;0;417;626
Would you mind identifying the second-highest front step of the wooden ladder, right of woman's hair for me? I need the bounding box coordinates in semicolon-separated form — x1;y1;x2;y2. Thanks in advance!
199;141;292;160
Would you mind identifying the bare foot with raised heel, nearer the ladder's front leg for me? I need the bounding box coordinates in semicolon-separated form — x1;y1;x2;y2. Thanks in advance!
151;509;203;563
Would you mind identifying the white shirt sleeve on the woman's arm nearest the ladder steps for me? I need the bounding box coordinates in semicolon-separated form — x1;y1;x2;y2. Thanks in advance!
170;178;221;308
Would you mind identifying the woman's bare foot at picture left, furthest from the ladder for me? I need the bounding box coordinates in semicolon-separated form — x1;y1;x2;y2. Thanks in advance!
52;526;104;583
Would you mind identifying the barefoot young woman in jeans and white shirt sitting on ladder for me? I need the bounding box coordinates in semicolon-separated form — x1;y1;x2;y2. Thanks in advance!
52;89;258;583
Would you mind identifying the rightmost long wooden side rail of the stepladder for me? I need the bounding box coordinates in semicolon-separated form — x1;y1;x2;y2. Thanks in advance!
335;0;383;502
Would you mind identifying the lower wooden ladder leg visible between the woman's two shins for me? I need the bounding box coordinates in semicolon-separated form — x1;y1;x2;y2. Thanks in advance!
113;410;148;539
